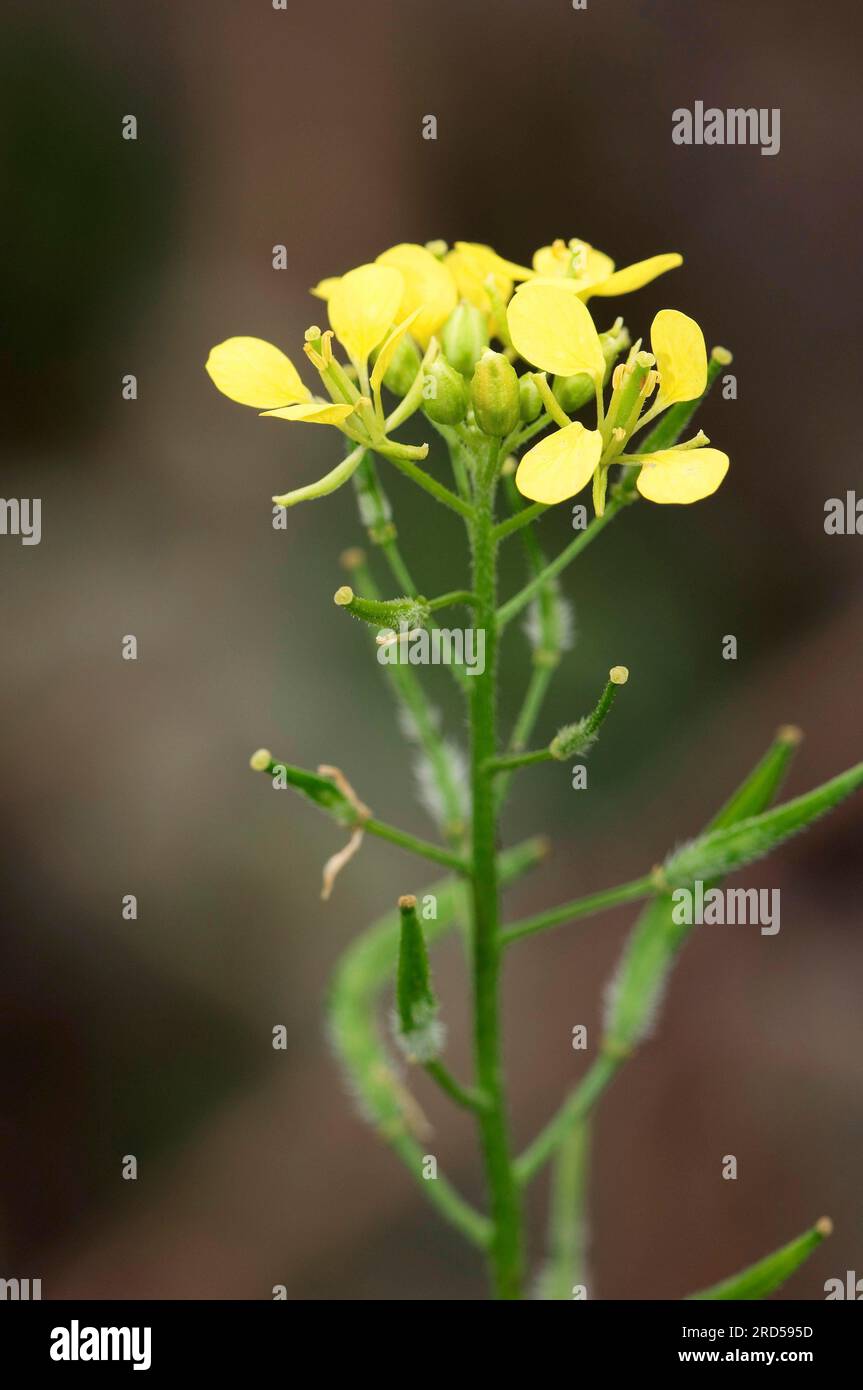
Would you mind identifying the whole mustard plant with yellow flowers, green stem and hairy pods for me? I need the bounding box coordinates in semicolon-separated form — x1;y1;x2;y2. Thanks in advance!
207;240;863;1300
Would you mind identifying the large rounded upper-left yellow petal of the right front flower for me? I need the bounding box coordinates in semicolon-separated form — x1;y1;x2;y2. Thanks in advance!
506;281;606;381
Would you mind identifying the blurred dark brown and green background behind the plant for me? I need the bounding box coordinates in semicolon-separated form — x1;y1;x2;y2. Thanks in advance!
0;0;863;1300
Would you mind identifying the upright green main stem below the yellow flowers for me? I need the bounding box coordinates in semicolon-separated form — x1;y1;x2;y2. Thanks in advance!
470;445;523;1298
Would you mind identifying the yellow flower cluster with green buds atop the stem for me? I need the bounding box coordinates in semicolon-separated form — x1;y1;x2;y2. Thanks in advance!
207;240;728;514
